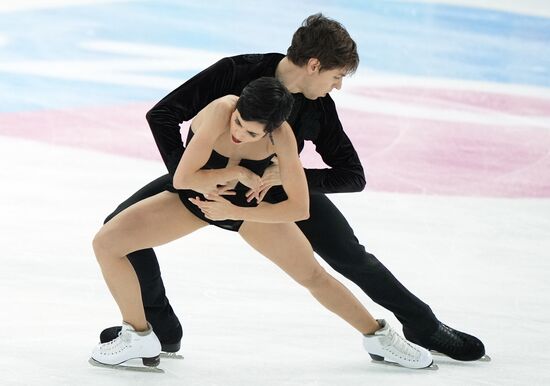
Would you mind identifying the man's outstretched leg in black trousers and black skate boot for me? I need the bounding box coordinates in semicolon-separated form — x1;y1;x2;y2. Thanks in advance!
297;194;485;360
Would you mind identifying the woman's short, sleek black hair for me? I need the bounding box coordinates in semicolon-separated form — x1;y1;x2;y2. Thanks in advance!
237;77;294;137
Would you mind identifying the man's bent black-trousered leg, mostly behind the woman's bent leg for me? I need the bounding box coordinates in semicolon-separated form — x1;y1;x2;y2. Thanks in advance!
101;174;183;352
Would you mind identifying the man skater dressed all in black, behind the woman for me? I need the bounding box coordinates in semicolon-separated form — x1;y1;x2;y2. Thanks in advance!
101;14;485;361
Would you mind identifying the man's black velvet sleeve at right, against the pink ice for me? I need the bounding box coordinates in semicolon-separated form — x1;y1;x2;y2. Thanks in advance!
305;95;366;193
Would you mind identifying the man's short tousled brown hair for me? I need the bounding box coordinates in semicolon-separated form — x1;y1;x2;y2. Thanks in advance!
286;13;359;74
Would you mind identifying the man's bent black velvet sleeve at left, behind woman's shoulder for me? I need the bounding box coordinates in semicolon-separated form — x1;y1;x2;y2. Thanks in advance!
146;58;235;176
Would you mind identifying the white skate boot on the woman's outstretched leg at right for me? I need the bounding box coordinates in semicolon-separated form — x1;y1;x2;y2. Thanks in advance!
363;320;433;369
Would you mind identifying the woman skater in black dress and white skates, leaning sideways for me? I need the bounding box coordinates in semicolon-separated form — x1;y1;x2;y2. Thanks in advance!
92;77;432;368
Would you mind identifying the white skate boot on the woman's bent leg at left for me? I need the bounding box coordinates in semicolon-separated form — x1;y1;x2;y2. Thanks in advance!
92;323;160;366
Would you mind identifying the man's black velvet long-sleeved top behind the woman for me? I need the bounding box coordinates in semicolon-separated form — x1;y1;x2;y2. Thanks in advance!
147;53;365;193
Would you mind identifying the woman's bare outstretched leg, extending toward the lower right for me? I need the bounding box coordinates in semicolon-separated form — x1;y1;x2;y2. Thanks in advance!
239;222;380;334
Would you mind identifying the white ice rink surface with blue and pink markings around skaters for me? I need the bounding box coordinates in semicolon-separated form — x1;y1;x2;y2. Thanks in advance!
0;0;550;386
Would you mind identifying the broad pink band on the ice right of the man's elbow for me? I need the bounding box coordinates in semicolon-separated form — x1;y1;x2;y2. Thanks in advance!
336;110;550;197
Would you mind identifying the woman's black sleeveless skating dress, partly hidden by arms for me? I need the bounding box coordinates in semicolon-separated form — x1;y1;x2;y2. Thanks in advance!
166;129;275;232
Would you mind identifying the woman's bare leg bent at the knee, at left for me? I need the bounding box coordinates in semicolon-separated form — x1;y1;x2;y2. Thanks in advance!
93;192;207;331
